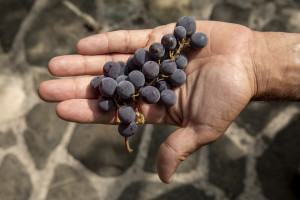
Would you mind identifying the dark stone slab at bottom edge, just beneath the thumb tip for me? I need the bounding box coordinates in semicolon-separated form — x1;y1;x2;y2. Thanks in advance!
118;182;215;200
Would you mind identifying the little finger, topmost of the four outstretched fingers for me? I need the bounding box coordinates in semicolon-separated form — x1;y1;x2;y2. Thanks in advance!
77;29;151;55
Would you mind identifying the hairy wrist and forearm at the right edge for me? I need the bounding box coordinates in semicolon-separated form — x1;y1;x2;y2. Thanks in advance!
251;32;300;101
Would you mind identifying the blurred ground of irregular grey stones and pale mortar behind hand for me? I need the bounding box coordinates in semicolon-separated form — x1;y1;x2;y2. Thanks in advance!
0;0;300;200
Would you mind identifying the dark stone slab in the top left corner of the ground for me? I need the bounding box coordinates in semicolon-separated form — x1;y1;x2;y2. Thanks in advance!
0;0;34;52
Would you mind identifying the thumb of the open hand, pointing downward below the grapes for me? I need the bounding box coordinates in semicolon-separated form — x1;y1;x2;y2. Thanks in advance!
157;125;221;183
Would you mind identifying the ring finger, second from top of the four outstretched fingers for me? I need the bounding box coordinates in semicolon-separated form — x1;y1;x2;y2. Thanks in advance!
48;54;130;76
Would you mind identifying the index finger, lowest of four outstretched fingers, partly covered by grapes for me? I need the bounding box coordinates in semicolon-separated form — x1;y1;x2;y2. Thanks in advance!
56;99;175;125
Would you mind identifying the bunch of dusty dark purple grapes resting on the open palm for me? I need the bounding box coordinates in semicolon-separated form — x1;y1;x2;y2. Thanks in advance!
90;16;208;152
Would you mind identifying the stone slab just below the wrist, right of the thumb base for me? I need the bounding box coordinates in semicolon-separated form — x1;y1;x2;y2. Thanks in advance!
236;102;289;136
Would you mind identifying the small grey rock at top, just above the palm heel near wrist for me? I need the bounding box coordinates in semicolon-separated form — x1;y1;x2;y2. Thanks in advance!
210;3;250;26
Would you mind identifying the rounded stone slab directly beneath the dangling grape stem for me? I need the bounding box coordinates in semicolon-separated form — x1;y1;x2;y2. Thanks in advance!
68;124;143;176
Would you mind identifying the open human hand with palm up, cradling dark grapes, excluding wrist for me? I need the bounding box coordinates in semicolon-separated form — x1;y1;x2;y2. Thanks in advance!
38;21;256;183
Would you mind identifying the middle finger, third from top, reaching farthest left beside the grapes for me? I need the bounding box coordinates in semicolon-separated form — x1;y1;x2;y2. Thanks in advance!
38;77;98;102
